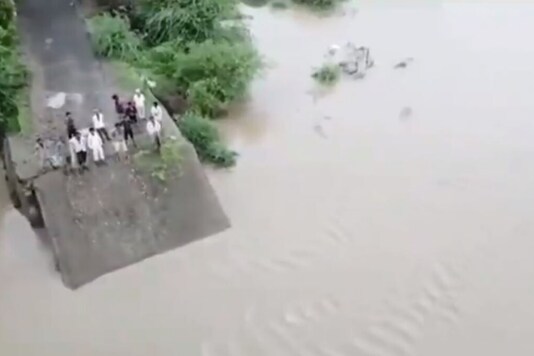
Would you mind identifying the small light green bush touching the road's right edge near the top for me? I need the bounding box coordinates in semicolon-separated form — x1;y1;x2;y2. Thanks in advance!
89;13;142;62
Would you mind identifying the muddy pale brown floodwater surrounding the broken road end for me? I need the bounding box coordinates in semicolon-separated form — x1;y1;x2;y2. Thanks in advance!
0;3;534;356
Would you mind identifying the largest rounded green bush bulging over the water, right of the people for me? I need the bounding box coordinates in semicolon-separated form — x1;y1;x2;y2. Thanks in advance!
147;40;260;115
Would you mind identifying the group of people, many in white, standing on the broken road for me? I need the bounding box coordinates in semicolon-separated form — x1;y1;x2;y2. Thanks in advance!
57;89;163;171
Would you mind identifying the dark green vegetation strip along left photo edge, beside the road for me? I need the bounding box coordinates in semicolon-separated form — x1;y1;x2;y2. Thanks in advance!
0;0;28;133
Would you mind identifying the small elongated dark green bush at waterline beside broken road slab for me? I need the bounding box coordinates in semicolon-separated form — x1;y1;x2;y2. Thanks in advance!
178;112;237;167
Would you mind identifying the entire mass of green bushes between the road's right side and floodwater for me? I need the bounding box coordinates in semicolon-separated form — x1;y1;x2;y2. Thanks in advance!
89;0;261;167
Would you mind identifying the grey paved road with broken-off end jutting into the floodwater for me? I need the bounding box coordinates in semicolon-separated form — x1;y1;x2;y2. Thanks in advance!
17;0;229;288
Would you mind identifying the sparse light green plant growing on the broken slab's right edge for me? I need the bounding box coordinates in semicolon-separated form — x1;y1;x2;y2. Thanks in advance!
133;137;183;182
